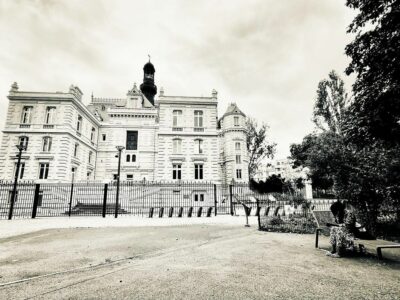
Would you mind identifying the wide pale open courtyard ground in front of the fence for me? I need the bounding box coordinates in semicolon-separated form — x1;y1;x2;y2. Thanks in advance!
0;217;400;299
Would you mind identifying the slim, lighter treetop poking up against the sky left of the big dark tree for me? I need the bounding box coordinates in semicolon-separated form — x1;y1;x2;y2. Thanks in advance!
313;71;350;135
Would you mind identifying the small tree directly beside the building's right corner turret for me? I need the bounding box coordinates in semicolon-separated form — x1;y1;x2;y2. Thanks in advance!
246;118;276;178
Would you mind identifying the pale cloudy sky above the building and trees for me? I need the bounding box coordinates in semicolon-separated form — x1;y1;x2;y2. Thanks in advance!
0;0;355;158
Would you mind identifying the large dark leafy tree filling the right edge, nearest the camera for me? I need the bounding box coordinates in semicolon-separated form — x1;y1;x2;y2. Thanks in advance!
336;0;400;237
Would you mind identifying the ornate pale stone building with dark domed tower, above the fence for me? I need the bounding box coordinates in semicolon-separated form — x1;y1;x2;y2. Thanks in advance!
0;61;248;183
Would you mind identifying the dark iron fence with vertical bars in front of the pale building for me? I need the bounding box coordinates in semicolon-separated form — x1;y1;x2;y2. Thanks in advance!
0;181;235;219
